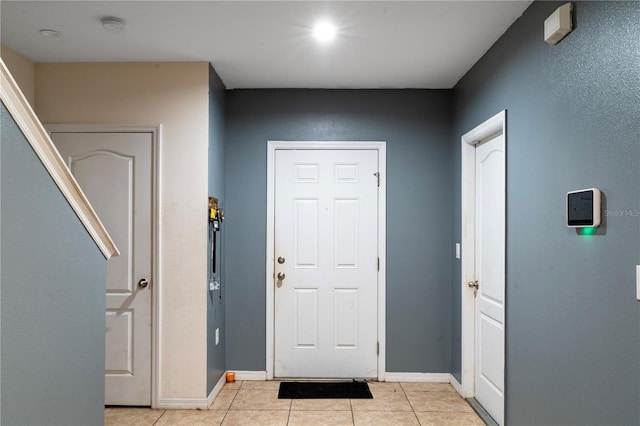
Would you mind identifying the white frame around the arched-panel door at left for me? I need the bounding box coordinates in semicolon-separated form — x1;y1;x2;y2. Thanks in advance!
45;123;162;408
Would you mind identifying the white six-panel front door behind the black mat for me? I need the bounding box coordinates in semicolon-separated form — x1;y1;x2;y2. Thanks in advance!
274;150;378;378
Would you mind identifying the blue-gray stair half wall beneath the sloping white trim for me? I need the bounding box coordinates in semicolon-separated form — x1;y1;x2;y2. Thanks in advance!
0;105;106;426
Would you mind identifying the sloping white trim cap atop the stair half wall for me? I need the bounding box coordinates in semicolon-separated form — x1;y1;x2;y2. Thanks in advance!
0;59;120;259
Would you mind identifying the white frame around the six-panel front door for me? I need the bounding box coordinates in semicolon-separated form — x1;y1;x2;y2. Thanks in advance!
265;141;387;381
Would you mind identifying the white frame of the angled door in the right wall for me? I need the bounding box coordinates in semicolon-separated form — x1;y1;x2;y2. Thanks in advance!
460;110;507;398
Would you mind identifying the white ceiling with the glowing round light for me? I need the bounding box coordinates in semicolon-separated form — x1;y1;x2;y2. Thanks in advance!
0;0;528;89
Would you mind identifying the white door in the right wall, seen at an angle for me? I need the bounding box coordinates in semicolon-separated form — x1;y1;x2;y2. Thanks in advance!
475;134;506;424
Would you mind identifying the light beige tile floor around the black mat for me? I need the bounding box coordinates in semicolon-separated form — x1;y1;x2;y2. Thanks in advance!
104;381;484;426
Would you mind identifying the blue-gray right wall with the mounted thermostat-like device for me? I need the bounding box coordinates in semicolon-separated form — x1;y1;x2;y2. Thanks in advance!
452;2;640;425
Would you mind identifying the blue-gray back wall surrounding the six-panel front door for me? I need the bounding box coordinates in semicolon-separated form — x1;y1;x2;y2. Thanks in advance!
225;90;453;373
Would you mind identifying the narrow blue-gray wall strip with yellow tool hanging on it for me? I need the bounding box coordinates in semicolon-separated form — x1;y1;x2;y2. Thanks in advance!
208;65;226;394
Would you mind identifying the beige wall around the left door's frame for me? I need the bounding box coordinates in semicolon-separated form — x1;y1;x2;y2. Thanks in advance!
35;62;209;406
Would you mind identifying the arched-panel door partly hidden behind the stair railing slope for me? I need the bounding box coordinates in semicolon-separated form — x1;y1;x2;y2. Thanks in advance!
51;132;153;406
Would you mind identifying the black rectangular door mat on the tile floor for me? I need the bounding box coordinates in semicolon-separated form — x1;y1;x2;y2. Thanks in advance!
278;382;373;399
